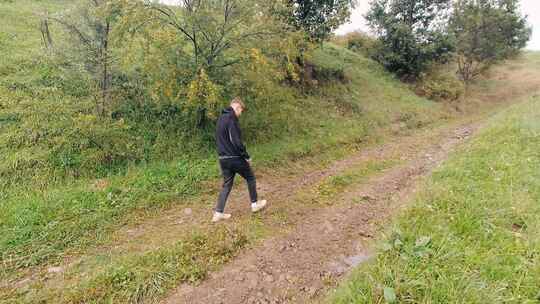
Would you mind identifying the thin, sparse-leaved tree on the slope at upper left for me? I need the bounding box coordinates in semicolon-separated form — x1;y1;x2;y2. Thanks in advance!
47;0;120;116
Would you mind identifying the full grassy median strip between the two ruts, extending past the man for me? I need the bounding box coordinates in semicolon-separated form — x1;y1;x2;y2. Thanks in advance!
0;140;397;303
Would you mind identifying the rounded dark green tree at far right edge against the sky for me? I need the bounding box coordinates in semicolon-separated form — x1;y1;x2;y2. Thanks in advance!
450;0;531;84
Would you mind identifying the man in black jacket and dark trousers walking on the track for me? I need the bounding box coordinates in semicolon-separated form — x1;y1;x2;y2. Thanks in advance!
212;97;266;222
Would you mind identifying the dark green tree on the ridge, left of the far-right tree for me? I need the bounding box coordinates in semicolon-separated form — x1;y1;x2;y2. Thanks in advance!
366;0;453;78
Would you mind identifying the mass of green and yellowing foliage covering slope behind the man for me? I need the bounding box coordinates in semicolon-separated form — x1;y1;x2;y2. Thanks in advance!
0;0;362;189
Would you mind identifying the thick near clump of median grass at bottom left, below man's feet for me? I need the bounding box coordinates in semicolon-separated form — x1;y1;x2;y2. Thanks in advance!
6;227;247;303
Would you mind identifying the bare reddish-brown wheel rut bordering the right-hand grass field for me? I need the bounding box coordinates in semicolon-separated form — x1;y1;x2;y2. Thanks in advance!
164;123;479;304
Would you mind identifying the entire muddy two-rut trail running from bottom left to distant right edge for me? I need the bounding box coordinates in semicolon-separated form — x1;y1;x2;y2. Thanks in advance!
5;52;540;304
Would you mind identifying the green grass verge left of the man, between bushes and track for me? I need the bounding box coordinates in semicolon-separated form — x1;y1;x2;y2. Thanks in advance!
2;160;215;269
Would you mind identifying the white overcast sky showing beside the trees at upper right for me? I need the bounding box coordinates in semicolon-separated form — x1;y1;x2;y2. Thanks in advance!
337;0;540;50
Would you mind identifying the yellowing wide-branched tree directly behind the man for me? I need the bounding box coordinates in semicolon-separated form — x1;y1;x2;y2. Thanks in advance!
117;0;288;128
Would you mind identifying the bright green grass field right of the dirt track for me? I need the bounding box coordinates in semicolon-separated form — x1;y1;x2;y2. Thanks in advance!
328;96;540;303
